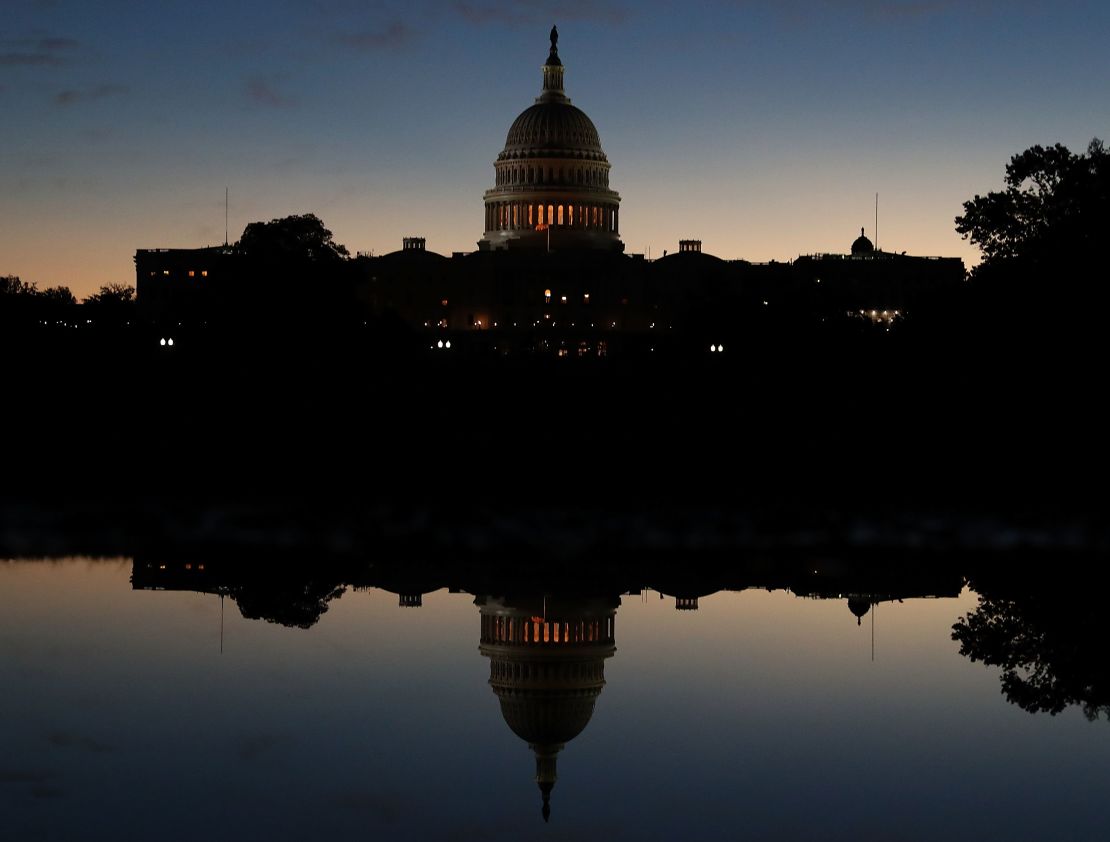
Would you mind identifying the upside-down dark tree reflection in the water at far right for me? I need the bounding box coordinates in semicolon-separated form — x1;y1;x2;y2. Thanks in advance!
952;581;1110;720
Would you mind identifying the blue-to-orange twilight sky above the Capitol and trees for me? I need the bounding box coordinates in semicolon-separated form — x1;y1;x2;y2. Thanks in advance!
0;0;1110;297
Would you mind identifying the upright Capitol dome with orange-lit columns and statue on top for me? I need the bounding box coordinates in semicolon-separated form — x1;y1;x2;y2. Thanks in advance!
478;28;624;251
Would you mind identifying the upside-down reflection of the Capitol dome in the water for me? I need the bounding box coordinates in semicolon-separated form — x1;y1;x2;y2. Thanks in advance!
475;597;619;820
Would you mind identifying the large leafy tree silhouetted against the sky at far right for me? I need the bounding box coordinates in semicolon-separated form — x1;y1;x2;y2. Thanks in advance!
956;139;1110;271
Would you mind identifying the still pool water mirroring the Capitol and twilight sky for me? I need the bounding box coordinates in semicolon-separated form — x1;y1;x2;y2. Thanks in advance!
0;559;1110;840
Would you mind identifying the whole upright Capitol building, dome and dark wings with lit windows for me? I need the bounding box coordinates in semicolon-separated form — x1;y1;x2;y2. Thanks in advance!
135;28;965;348
